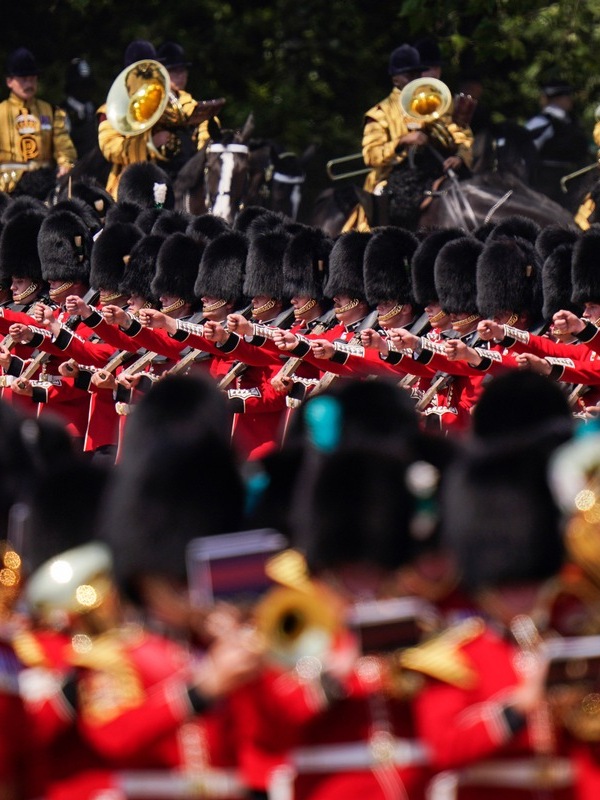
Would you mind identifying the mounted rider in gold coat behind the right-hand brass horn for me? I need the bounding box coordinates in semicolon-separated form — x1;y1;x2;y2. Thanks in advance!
344;44;473;230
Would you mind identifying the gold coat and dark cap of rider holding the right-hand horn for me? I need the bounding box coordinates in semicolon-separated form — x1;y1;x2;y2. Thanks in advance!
344;44;473;230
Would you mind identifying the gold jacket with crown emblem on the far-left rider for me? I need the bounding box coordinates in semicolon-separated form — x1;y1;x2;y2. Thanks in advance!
0;92;77;192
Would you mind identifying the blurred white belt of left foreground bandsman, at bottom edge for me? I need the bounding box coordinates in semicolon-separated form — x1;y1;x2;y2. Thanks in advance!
117;769;247;800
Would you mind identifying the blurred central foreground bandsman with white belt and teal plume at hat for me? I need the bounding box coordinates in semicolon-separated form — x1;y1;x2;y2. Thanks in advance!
232;383;452;800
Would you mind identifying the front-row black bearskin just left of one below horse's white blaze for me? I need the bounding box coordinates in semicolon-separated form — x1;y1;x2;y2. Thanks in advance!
152;231;203;304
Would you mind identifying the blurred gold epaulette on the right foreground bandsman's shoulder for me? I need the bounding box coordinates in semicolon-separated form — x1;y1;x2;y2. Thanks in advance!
399;617;485;689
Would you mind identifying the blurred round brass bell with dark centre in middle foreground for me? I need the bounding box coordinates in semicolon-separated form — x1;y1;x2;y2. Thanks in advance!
255;587;340;669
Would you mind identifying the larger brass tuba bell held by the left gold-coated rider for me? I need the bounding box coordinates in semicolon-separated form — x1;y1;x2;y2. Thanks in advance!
106;59;174;136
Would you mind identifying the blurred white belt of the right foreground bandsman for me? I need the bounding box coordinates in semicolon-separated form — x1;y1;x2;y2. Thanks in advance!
427;757;574;800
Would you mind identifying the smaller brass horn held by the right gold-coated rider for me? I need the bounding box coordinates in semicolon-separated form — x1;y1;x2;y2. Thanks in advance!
400;78;455;149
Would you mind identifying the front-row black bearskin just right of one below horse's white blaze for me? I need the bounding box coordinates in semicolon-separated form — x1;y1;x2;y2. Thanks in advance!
244;230;289;300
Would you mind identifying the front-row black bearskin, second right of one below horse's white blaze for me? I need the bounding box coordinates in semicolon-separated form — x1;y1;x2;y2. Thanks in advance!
283;226;333;300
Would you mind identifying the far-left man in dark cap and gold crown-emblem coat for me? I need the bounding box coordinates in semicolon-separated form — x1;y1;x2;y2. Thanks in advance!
0;47;77;199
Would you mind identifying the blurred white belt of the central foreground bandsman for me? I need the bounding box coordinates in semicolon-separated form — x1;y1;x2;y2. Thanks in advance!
290;739;429;773
